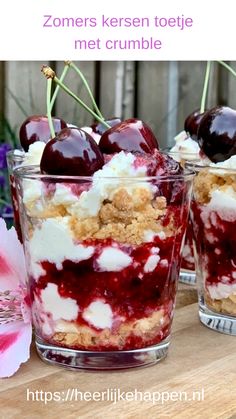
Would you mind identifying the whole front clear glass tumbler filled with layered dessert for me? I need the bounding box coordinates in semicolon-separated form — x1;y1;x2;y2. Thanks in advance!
14;166;194;369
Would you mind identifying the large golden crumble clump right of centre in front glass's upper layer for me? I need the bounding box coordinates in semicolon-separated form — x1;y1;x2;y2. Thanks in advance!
70;188;170;245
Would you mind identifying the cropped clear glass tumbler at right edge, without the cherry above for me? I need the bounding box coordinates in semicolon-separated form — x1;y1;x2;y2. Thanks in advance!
188;164;236;335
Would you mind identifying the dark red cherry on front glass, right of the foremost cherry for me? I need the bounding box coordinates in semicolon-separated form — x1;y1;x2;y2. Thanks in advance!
99;119;159;154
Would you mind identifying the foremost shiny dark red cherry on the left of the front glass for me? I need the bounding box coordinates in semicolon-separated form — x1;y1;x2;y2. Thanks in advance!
40;128;104;176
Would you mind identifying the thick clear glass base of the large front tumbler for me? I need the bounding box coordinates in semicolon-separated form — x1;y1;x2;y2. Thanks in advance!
35;336;170;370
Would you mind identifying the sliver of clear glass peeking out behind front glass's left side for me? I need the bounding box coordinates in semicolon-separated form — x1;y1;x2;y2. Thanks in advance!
7;149;25;243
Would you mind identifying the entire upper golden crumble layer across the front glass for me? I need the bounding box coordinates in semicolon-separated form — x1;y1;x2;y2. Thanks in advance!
27;187;181;245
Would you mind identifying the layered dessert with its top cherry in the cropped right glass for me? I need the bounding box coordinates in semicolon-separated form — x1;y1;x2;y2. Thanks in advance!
191;107;236;316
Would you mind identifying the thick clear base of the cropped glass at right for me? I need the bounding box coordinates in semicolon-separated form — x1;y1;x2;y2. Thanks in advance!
199;303;236;336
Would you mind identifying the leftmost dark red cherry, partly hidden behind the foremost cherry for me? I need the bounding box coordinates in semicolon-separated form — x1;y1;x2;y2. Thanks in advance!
19;115;67;151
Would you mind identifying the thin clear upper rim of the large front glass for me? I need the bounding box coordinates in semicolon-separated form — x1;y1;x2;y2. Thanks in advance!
13;165;195;182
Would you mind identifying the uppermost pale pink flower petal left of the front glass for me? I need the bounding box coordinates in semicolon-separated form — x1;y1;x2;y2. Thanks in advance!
0;218;26;291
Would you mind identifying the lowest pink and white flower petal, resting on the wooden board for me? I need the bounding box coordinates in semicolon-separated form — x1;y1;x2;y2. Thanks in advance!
0;321;32;378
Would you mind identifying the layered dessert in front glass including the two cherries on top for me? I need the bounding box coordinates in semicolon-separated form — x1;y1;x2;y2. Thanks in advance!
15;119;192;352
